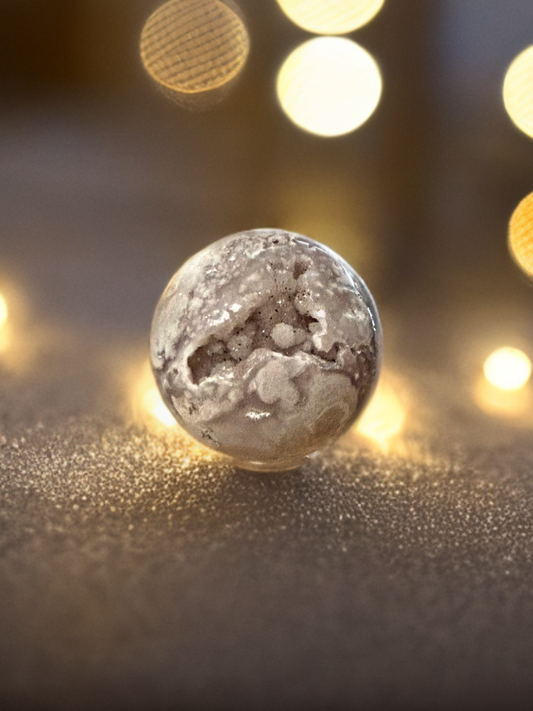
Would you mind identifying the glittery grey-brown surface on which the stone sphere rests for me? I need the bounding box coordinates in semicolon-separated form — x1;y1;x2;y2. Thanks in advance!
0;324;533;711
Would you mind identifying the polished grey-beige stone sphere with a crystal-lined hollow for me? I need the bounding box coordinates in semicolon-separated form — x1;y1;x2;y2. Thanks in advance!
151;229;382;471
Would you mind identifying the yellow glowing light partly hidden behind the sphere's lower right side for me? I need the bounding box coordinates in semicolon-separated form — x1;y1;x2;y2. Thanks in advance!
356;375;406;449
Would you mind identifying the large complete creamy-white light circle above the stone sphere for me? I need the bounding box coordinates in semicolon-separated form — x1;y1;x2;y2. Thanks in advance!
277;37;382;136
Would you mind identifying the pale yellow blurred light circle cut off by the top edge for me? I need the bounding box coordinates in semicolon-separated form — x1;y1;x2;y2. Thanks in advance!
278;0;385;35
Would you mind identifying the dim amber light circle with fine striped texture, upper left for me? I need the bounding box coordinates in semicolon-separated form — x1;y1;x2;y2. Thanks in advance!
141;0;250;94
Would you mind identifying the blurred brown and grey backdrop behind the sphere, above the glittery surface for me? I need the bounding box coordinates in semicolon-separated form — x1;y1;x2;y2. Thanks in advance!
0;0;533;400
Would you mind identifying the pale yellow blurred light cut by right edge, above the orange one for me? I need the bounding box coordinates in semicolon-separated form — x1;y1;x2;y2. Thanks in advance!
503;46;533;138
